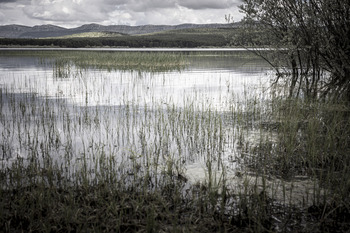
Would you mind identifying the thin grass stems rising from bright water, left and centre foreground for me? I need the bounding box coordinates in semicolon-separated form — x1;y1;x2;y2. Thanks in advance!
0;85;238;232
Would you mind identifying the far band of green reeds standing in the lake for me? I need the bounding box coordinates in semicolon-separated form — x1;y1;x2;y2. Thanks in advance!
0;50;187;78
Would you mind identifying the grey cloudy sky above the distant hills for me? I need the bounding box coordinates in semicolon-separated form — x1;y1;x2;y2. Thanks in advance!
0;0;242;28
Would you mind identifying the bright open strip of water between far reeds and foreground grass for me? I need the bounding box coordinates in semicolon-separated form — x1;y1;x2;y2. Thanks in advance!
0;50;270;110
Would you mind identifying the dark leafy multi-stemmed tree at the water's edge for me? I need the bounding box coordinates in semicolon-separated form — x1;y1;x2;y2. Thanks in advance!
241;0;350;101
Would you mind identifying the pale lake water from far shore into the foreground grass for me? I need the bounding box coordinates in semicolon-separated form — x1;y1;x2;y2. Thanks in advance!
6;50;320;204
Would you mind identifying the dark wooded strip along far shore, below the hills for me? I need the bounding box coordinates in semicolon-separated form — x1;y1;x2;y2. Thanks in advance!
0;29;235;48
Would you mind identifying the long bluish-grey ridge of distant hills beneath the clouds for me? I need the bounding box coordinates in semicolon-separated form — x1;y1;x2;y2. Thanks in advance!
0;23;240;38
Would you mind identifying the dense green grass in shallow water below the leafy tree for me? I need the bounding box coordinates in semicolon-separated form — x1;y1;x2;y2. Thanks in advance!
234;82;350;231
